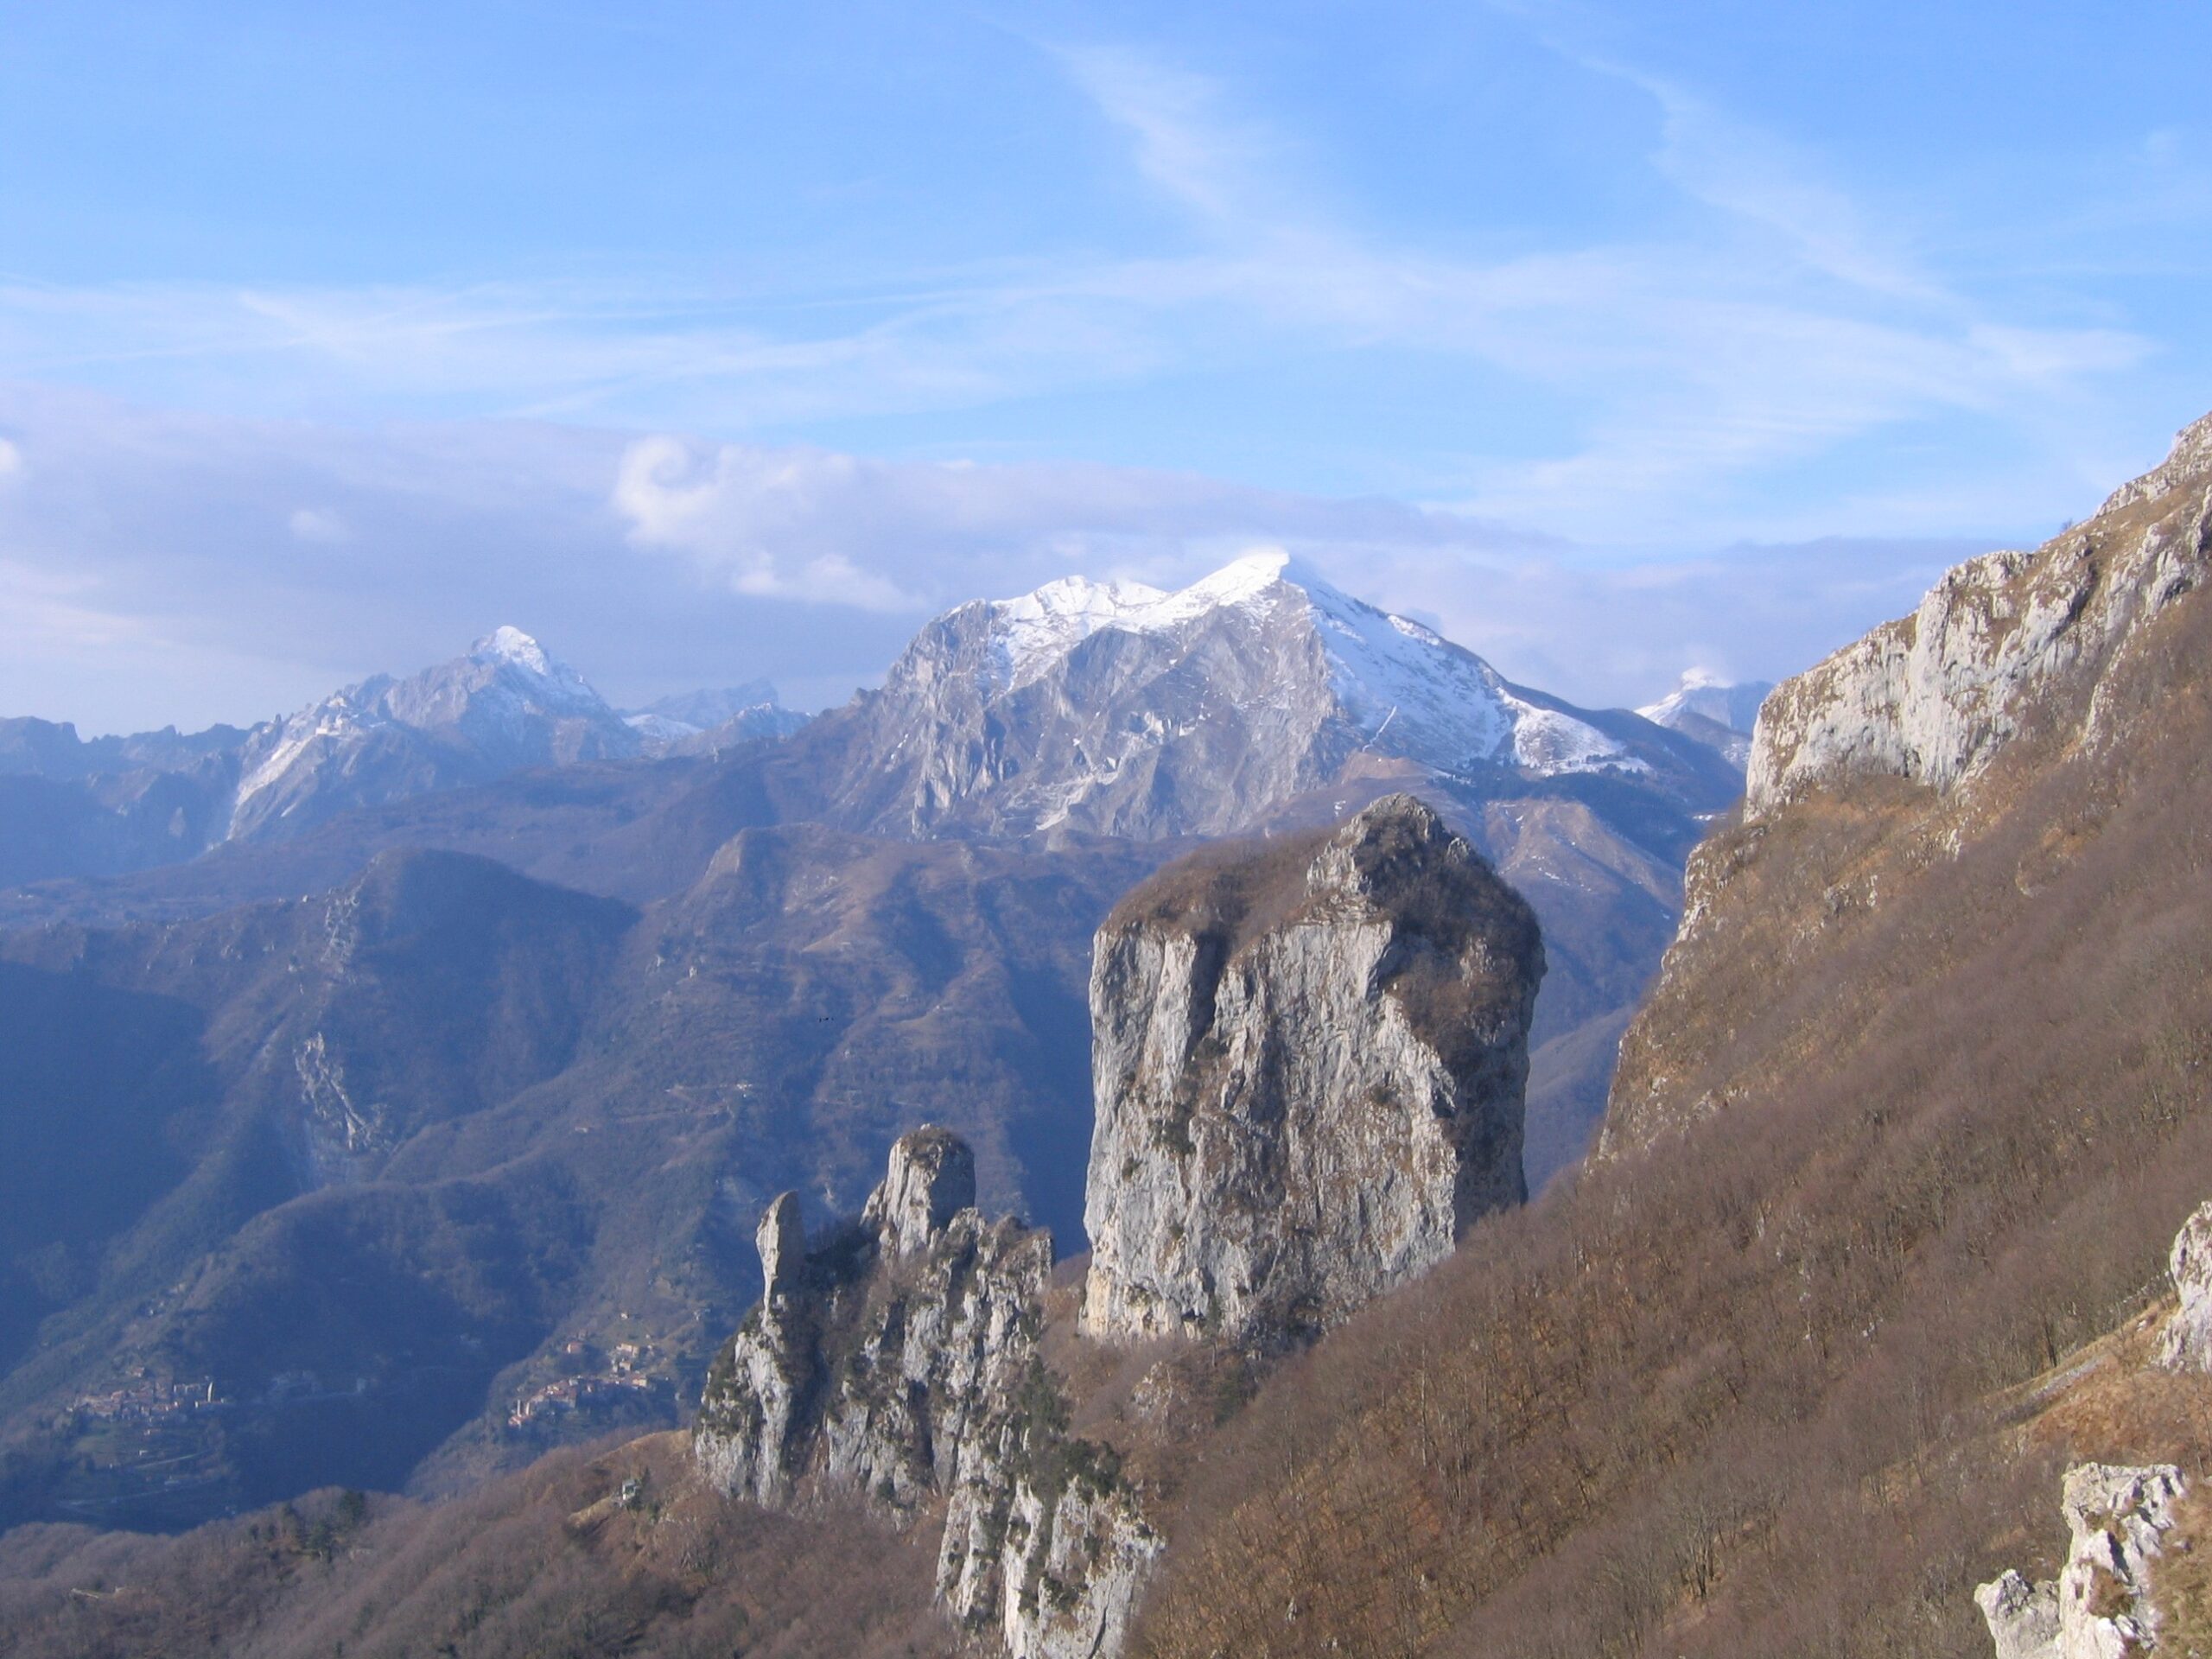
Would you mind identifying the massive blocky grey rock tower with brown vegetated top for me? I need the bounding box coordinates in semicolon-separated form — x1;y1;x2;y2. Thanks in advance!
1084;794;1544;1347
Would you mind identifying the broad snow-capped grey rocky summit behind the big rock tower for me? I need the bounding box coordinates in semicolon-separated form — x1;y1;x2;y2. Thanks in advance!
814;550;1679;838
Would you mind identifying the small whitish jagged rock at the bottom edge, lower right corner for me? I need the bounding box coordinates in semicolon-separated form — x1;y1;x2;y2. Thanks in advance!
1974;1462;2185;1659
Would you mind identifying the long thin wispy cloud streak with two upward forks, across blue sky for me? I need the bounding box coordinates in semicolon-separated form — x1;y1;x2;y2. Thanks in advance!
0;30;2172;553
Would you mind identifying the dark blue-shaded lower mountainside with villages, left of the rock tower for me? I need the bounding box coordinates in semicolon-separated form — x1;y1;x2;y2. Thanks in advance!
0;827;1133;1524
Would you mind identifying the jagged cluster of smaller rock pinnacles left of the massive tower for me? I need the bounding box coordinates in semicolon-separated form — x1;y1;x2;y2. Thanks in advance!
692;1128;1161;1659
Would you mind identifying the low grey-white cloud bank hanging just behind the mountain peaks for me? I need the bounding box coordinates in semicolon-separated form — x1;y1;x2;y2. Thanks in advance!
0;387;2008;730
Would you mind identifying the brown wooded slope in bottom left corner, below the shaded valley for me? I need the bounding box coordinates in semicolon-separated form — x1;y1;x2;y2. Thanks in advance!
0;1433;953;1659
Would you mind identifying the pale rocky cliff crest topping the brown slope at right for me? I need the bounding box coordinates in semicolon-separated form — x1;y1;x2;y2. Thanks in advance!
1745;416;2212;821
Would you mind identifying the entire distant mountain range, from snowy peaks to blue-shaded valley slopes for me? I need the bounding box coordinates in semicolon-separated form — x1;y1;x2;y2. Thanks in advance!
0;560;1738;1526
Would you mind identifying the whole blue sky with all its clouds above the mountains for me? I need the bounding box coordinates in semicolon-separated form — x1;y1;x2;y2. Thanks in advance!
0;0;2212;728
